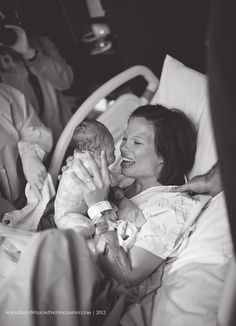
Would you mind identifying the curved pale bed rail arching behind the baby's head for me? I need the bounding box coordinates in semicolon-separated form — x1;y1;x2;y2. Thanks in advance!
49;65;159;185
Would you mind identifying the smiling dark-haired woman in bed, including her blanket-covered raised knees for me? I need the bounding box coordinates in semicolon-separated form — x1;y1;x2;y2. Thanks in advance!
0;105;206;325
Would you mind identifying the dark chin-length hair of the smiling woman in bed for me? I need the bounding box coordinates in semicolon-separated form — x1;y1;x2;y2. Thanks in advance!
129;105;197;185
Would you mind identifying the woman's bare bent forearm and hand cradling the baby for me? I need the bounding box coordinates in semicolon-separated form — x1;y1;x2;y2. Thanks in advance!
71;152;163;286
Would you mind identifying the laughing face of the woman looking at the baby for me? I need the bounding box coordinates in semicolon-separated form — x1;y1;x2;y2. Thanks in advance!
120;117;163;183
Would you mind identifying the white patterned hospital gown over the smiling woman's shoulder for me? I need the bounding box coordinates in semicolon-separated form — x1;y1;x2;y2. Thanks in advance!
134;186;210;259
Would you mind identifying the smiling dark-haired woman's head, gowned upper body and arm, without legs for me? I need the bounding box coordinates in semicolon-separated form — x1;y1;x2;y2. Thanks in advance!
75;105;202;288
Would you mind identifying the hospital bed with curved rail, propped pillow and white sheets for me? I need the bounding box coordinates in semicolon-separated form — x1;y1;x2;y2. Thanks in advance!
0;56;236;326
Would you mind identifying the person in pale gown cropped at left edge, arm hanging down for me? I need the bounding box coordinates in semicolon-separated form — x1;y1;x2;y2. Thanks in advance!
0;83;52;216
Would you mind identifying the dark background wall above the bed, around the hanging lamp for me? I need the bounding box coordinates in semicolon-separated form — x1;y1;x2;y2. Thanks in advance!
19;0;210;86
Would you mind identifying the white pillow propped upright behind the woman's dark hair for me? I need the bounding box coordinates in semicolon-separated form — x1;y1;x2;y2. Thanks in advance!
152;55;217;179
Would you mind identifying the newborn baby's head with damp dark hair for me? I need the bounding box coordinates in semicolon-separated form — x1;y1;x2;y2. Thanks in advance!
71;120;115;165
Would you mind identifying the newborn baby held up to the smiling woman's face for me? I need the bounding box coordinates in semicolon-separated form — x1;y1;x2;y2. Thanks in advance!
54;120;145;250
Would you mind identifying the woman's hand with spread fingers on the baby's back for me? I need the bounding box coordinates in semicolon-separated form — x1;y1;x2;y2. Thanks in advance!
71;151;111;207
